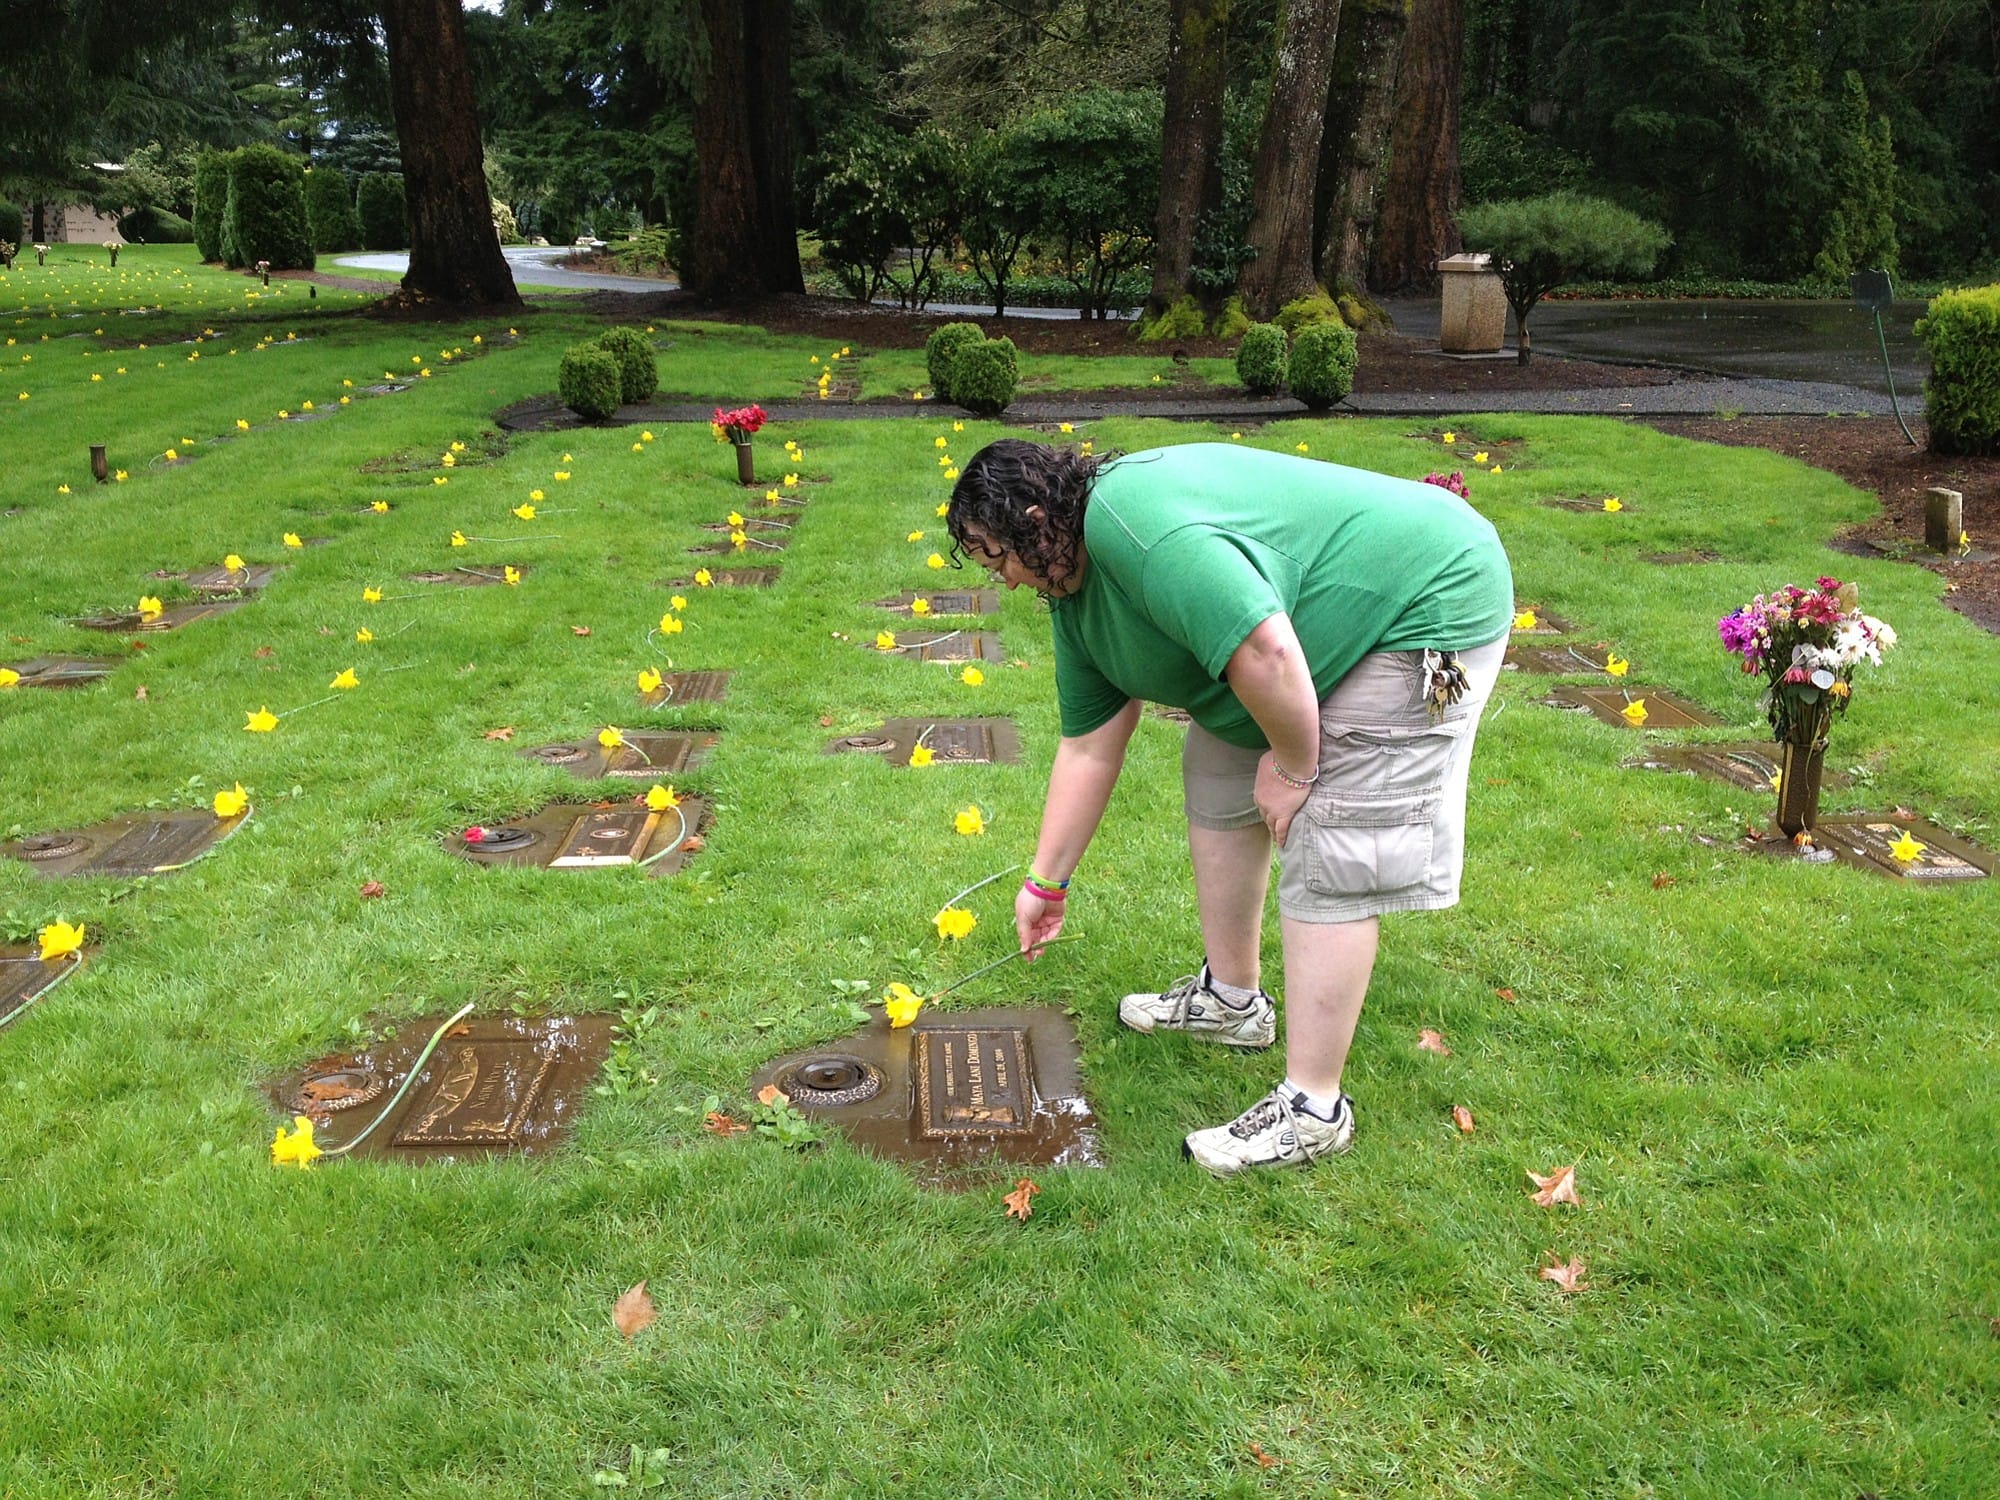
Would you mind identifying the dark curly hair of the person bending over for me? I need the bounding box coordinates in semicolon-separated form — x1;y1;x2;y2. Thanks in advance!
944;438;1104;584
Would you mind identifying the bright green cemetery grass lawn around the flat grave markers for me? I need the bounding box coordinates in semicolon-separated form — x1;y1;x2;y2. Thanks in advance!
0;250;2000;1500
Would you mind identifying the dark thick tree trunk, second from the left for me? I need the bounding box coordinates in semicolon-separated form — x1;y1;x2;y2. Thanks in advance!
680;0;804;298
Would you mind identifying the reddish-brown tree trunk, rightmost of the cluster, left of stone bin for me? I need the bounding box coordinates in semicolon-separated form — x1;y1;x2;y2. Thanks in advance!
1368;0;1466;292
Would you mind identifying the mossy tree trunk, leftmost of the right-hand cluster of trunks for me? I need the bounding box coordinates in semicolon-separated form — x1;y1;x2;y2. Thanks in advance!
1146;0;1230;312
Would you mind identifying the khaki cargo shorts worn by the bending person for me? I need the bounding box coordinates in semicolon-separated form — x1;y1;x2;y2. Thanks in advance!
1180;638;1506;922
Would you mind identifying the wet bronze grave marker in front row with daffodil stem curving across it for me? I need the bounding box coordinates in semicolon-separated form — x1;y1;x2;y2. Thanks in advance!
268;1016;614;1162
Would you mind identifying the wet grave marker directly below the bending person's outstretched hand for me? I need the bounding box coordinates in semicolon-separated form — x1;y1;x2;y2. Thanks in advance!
750;1006;1102;1180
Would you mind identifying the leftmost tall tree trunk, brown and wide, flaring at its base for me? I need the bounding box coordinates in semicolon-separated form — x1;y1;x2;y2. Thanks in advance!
382;0;520;308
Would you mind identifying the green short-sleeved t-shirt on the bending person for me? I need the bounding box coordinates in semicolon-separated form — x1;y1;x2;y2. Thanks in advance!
1052;442;1514;748
